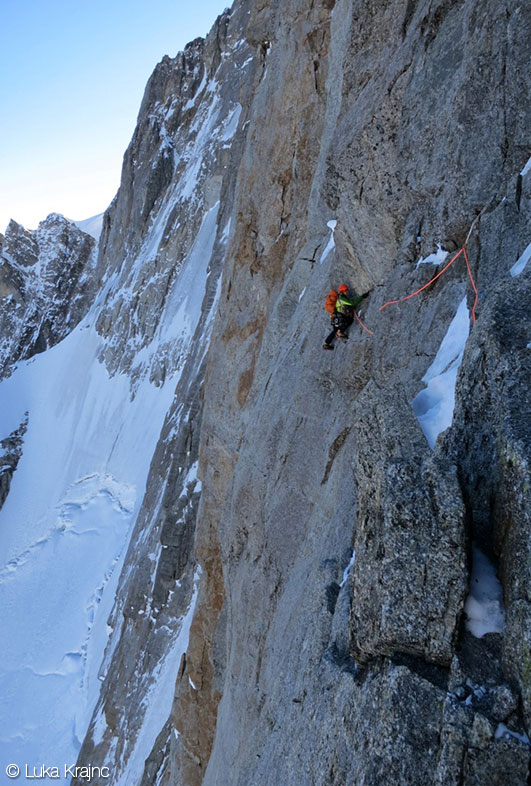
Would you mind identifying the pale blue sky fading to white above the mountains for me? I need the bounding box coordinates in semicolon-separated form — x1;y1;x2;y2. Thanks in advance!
0;0;230;233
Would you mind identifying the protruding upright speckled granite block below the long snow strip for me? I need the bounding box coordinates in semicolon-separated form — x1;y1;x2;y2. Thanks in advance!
351;384;466;665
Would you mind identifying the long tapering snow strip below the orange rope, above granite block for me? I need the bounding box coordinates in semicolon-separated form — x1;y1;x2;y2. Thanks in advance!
411;297;470;449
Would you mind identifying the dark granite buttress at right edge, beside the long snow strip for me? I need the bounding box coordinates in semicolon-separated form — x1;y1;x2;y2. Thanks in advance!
452;264;531;728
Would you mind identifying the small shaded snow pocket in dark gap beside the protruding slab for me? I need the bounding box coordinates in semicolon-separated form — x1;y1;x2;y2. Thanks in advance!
465;547;505;639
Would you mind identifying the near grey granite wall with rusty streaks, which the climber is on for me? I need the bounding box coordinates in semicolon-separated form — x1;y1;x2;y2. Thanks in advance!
173;0;531;786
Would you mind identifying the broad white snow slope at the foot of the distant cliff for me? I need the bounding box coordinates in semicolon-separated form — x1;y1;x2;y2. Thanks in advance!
0;204;222;767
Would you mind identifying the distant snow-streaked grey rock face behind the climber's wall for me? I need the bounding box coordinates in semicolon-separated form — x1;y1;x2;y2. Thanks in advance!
72;7;258;783
